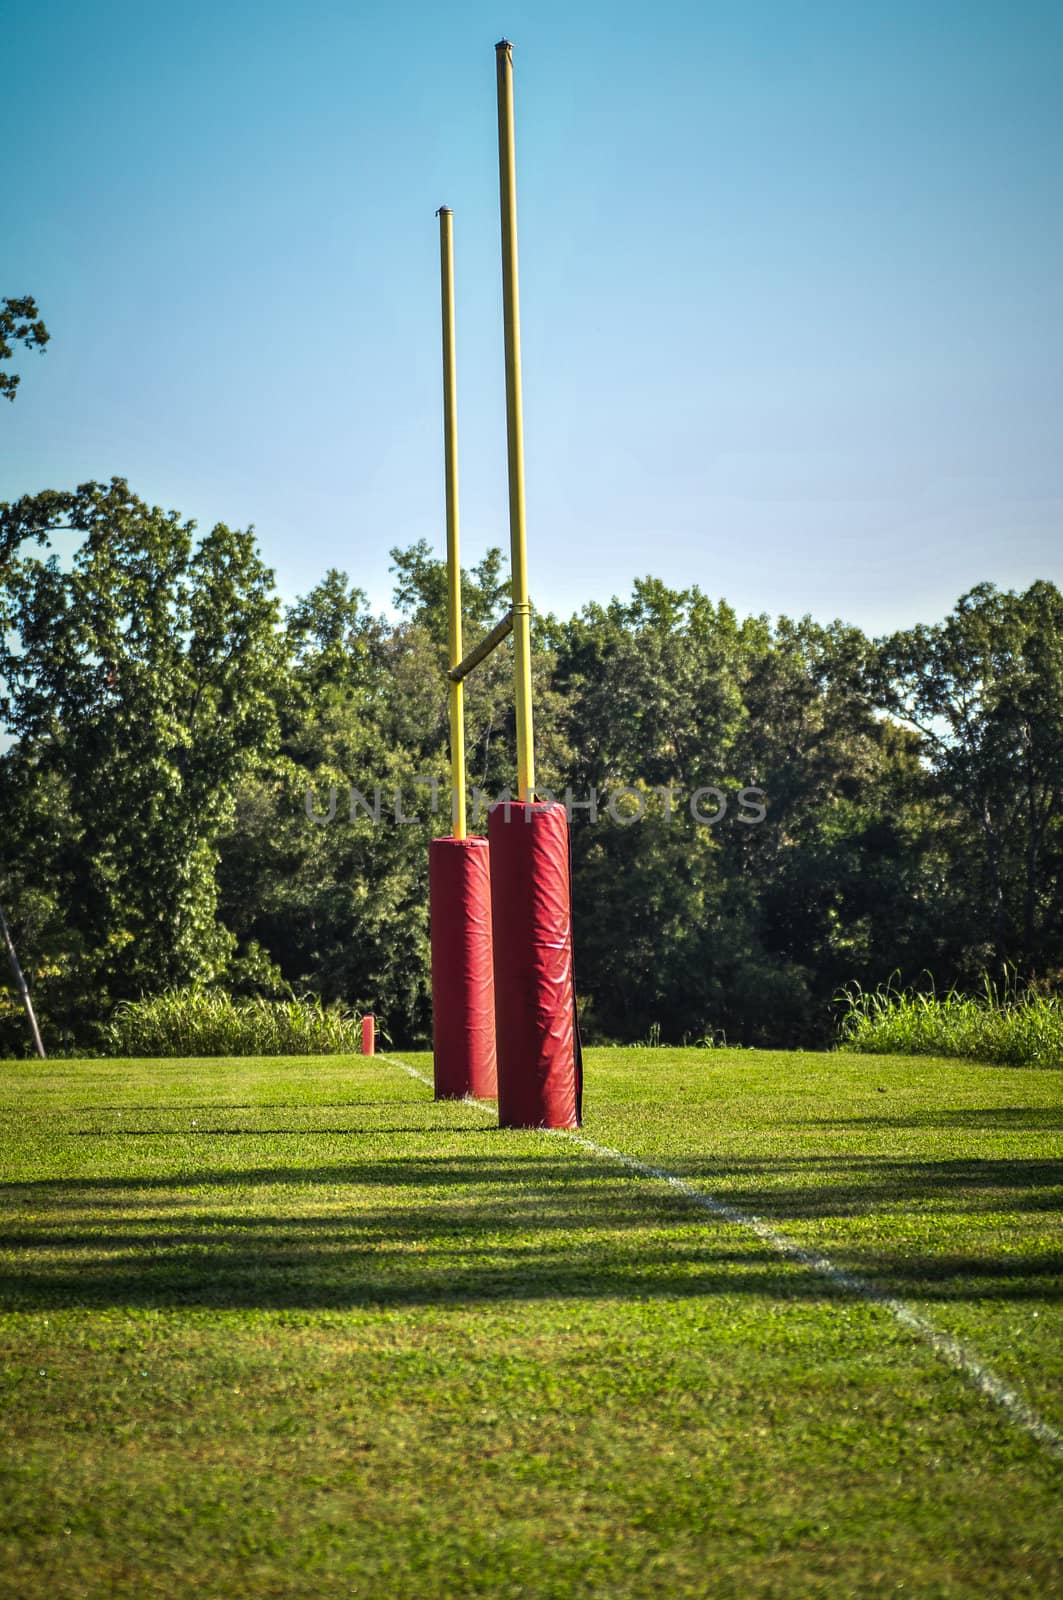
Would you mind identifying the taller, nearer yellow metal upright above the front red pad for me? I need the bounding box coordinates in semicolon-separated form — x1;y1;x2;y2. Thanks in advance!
495;38;535;800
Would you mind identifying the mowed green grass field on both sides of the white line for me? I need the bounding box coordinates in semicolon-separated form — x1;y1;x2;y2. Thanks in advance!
0;1050;1063;1600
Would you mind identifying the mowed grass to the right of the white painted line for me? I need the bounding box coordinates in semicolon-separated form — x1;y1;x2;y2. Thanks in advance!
563;1050;1063;1432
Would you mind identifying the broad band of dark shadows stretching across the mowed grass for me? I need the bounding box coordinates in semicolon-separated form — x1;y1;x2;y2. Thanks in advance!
0;1152;1063;1309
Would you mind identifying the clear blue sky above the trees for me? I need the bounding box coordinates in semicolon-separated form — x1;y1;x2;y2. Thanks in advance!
0;0;1063;632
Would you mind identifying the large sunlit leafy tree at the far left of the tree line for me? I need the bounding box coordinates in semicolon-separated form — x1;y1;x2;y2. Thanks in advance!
0;478;285;1024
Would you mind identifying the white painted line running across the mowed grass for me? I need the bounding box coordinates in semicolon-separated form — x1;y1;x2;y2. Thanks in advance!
379;1056;1063;1459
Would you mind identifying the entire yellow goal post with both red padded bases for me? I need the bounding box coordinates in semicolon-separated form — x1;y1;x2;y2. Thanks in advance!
429;38;583;1128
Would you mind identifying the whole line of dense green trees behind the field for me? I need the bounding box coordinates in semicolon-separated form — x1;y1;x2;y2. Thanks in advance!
0;478;1063;1053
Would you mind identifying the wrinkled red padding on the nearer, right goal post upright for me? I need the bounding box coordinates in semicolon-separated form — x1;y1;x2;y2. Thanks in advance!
487;803;583;1128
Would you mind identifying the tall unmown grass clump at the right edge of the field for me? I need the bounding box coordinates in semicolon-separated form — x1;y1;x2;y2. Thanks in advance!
837;971;1063;1067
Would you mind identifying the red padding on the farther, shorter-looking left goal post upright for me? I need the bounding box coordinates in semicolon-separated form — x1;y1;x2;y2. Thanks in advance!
429;838;498;1099
